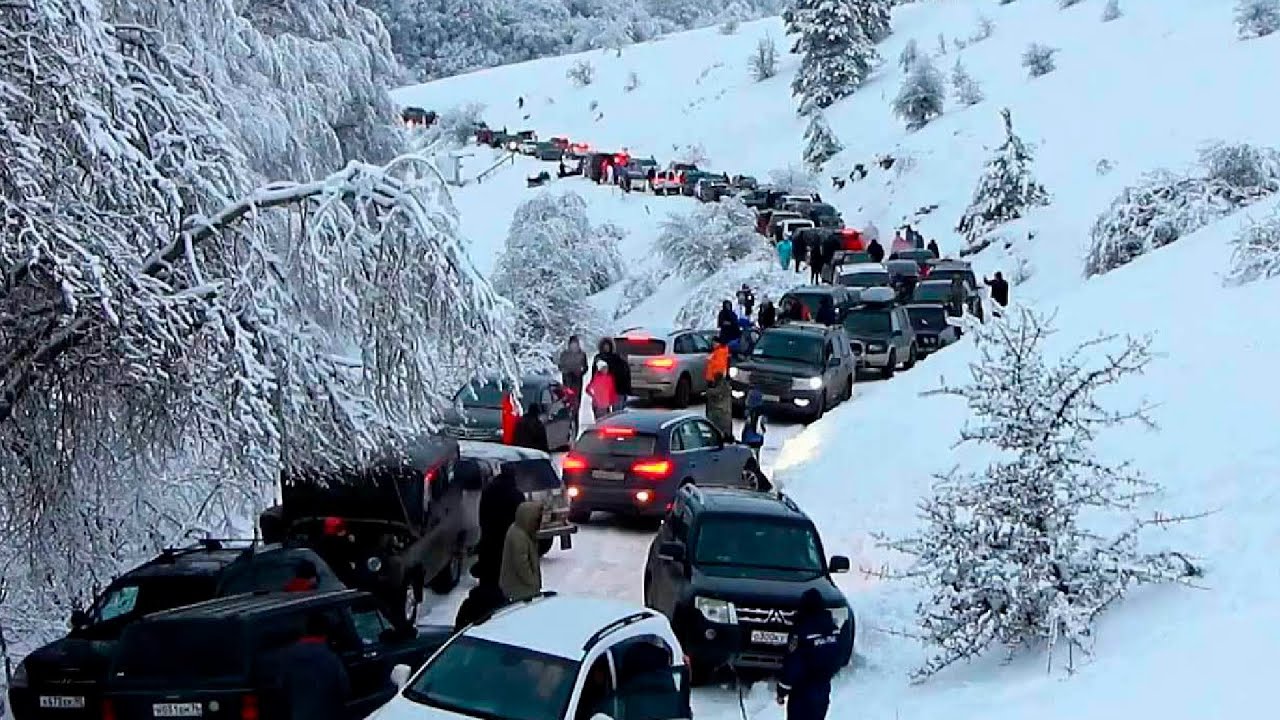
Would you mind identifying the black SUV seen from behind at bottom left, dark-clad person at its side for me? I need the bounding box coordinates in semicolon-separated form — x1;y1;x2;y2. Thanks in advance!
101;591;452;720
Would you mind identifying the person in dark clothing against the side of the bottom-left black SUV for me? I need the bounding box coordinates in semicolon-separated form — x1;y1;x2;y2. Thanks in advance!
260;612;351;720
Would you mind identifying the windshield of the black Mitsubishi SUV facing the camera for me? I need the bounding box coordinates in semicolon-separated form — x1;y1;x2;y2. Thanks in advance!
694;516;823;574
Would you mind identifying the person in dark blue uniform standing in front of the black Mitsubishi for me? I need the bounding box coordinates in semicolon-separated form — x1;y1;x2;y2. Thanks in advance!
778;588;841;720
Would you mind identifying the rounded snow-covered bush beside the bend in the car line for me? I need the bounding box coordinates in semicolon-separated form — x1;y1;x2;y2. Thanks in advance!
657;197;768;279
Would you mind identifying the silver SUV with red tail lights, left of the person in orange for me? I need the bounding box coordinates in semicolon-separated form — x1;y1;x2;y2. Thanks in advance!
613;328;712;407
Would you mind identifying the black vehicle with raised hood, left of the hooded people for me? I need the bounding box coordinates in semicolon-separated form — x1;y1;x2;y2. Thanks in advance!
259;436;479;625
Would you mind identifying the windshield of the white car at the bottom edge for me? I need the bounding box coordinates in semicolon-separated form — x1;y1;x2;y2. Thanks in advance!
404;635;579;720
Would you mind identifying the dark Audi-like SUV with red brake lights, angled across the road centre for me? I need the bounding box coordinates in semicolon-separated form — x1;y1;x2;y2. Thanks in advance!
563;410;764;524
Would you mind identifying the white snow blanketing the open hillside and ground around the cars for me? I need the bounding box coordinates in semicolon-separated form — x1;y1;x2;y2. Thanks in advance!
398;0;1280;720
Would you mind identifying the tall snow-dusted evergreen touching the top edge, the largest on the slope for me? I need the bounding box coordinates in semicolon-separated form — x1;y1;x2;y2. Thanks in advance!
783;0;879;113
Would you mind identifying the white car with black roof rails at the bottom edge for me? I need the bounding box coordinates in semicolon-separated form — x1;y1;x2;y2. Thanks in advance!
369;592;692;720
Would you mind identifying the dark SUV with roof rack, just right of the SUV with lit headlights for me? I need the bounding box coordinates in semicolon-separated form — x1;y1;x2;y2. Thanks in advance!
844;287;920;378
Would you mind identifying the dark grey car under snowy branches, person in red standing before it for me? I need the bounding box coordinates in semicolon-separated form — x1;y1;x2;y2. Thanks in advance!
440;374;577;450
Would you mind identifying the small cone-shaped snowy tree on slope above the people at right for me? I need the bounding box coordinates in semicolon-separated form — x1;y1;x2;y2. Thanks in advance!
956;108;1050;246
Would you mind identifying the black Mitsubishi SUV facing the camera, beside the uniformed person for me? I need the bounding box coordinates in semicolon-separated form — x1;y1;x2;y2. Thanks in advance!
644;486;855;679
